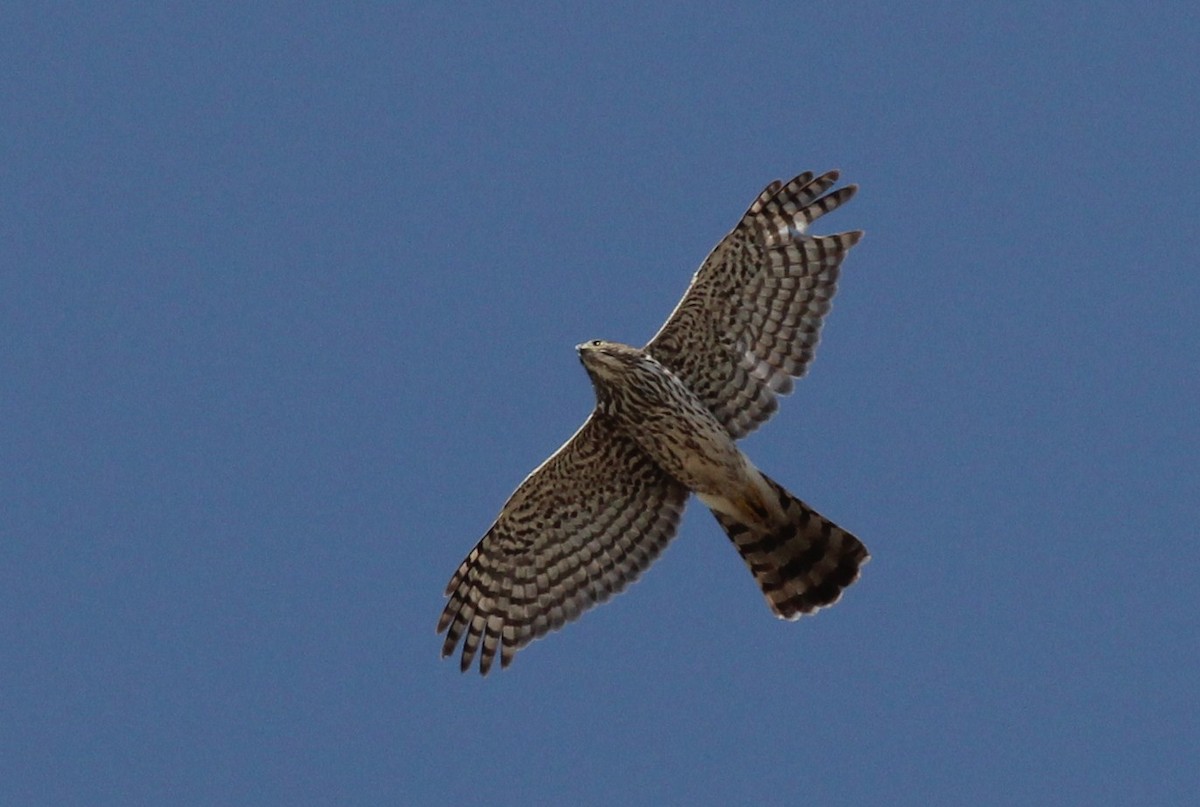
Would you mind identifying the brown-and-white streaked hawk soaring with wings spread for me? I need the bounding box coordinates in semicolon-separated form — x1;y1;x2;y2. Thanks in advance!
438;171;870;675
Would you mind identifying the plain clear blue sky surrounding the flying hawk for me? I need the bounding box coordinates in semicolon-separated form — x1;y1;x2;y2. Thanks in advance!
0;0;1200;806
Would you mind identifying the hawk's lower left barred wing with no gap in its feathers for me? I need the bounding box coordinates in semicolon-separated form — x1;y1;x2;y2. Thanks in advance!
438;412;689;675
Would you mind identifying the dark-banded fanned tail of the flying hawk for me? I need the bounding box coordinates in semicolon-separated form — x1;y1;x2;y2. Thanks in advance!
713;474;871;620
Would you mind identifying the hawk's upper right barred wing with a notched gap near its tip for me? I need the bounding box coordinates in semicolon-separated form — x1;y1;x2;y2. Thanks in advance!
646;171;863;438
